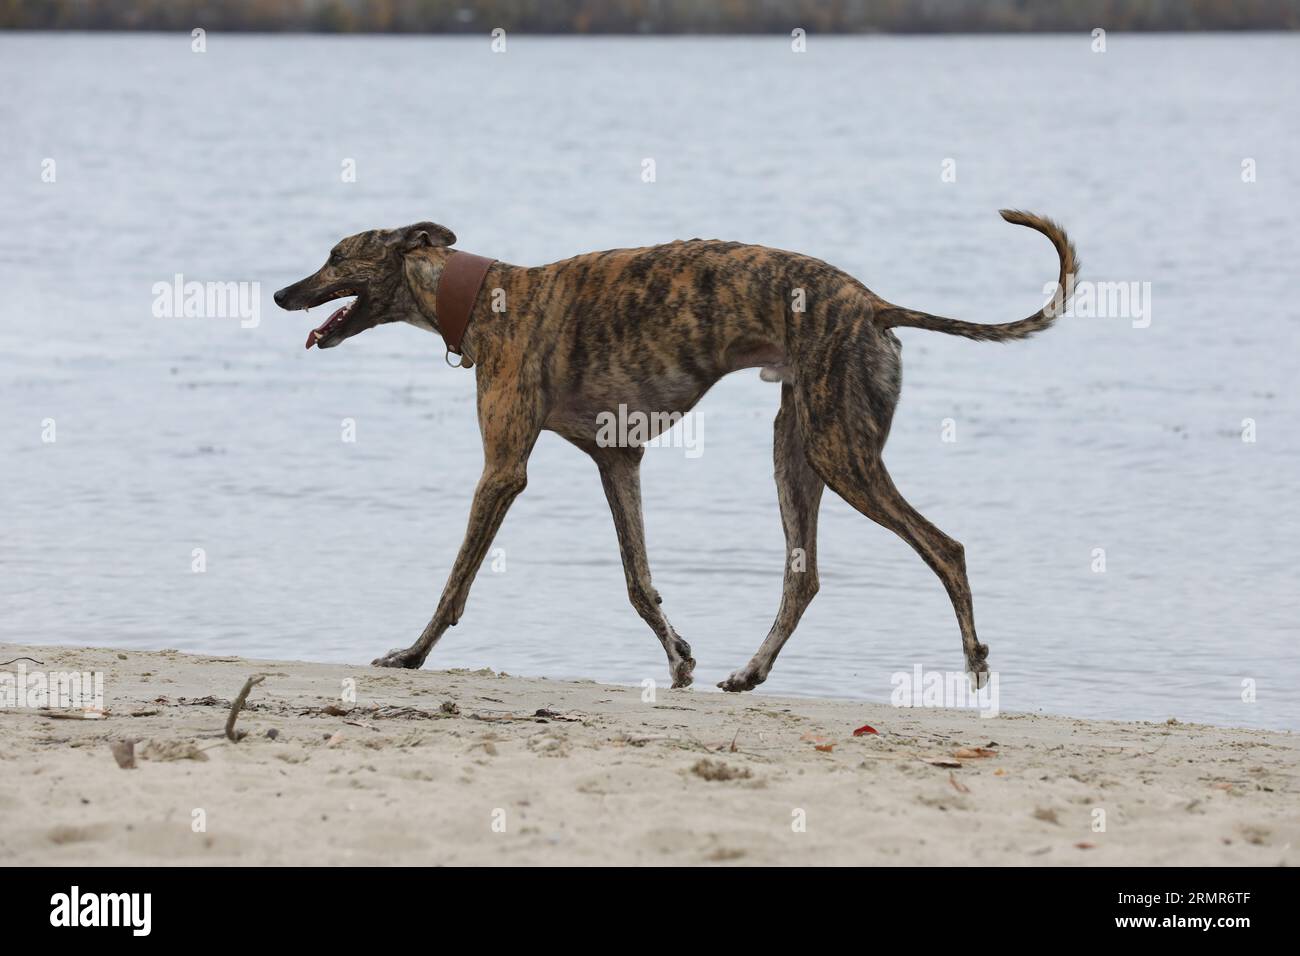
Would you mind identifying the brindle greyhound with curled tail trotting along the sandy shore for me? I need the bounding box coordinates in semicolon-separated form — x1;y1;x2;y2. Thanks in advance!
276;211;1078;691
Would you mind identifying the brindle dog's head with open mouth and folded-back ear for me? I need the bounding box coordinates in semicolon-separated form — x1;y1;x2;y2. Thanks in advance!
276;222;456;349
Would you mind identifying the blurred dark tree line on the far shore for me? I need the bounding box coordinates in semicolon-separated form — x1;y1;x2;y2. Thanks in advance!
0;0;1300;34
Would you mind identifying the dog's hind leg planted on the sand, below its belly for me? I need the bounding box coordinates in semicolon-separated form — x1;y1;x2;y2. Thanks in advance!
718;385;826;691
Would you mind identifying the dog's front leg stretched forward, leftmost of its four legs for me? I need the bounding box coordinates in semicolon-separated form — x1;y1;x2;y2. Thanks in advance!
372;460;528;667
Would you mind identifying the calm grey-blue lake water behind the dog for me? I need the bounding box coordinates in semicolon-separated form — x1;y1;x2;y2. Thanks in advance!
0;34;1300;728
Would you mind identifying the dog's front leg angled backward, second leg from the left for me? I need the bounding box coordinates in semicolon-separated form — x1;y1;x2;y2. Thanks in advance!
589;447;696;687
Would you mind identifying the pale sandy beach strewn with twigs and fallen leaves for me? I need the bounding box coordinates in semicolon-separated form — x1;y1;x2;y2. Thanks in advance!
0;645;1300;866
